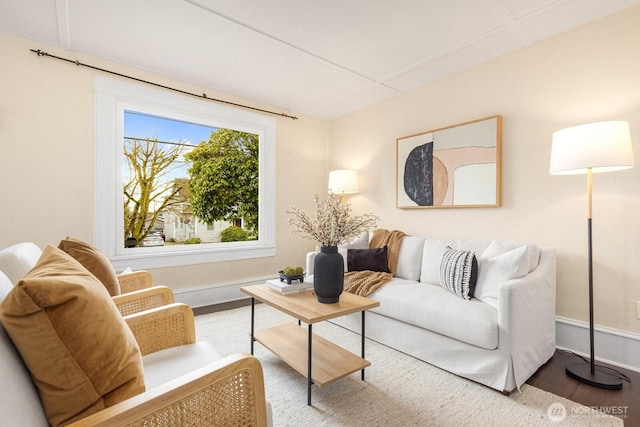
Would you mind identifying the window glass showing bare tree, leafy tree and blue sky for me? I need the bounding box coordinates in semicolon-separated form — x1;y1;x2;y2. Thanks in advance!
123;110;260;247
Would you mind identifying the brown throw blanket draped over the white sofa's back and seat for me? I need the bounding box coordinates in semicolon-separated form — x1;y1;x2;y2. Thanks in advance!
344;229;405;297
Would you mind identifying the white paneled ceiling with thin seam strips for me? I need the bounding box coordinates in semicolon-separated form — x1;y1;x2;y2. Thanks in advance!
0;0;640;119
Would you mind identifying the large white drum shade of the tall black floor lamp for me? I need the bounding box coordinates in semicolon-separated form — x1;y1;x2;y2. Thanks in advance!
549;121;633;175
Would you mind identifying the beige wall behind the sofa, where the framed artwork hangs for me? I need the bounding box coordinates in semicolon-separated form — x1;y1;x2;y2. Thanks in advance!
329;7;640;333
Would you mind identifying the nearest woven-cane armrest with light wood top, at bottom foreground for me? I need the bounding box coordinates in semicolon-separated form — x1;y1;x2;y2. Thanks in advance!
70;353;268;427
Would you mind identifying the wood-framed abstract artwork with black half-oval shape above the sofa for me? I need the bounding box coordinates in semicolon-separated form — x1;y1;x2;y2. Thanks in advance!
396;116;502;208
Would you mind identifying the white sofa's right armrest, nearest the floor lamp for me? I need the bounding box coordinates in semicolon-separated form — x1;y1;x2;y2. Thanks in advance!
498;248;556;387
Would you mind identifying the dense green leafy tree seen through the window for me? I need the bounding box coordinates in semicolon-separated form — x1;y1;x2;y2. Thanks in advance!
185;129;259;234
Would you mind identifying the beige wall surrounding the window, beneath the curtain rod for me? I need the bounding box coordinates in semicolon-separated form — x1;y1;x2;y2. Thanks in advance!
0;33;328;289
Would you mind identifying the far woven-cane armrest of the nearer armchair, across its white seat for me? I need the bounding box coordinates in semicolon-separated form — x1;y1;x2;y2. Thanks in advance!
124;303;196;356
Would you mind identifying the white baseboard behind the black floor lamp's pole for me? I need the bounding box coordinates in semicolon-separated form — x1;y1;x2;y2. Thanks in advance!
556;316;640;372
